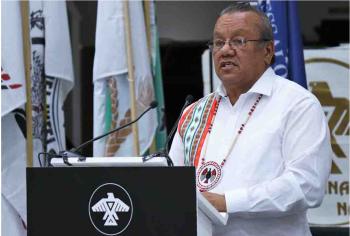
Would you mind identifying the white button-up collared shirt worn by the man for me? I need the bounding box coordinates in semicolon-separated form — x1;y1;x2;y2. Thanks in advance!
170;68;332;236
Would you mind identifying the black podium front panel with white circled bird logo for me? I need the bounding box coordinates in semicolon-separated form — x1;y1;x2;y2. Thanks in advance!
27;167;197;236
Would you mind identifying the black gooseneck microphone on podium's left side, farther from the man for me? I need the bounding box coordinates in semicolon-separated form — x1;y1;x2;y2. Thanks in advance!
50;101;158;166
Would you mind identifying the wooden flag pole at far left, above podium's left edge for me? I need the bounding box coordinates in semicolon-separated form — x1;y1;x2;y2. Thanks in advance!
21;1;33;167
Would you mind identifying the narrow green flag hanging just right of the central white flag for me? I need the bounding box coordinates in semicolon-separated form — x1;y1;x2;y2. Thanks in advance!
149;0;167;150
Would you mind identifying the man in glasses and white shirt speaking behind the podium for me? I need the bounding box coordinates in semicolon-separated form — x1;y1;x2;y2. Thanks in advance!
170;3;331;236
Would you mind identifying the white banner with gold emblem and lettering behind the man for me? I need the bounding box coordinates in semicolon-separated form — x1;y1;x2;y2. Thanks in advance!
304;46;350;226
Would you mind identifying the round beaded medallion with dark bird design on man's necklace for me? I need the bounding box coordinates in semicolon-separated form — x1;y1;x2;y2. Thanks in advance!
197;161;222;192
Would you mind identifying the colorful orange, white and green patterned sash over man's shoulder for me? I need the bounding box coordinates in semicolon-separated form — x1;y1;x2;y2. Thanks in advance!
178;93;218;167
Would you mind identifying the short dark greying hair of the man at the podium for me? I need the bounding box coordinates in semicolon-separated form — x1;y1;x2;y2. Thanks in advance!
219;2;275;65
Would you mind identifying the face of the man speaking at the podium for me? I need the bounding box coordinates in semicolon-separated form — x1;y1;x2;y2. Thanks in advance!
213;12;273;88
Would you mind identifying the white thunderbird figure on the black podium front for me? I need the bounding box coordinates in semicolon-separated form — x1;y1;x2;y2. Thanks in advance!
92;193;130;226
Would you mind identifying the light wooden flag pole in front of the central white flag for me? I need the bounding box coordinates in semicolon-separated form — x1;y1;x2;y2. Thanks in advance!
123;1;140;156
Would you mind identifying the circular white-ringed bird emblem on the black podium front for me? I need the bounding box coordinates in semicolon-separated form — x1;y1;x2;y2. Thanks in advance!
89;183;133;235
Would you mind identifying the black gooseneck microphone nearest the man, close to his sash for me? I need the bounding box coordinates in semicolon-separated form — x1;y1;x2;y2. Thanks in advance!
143;95;193;166
